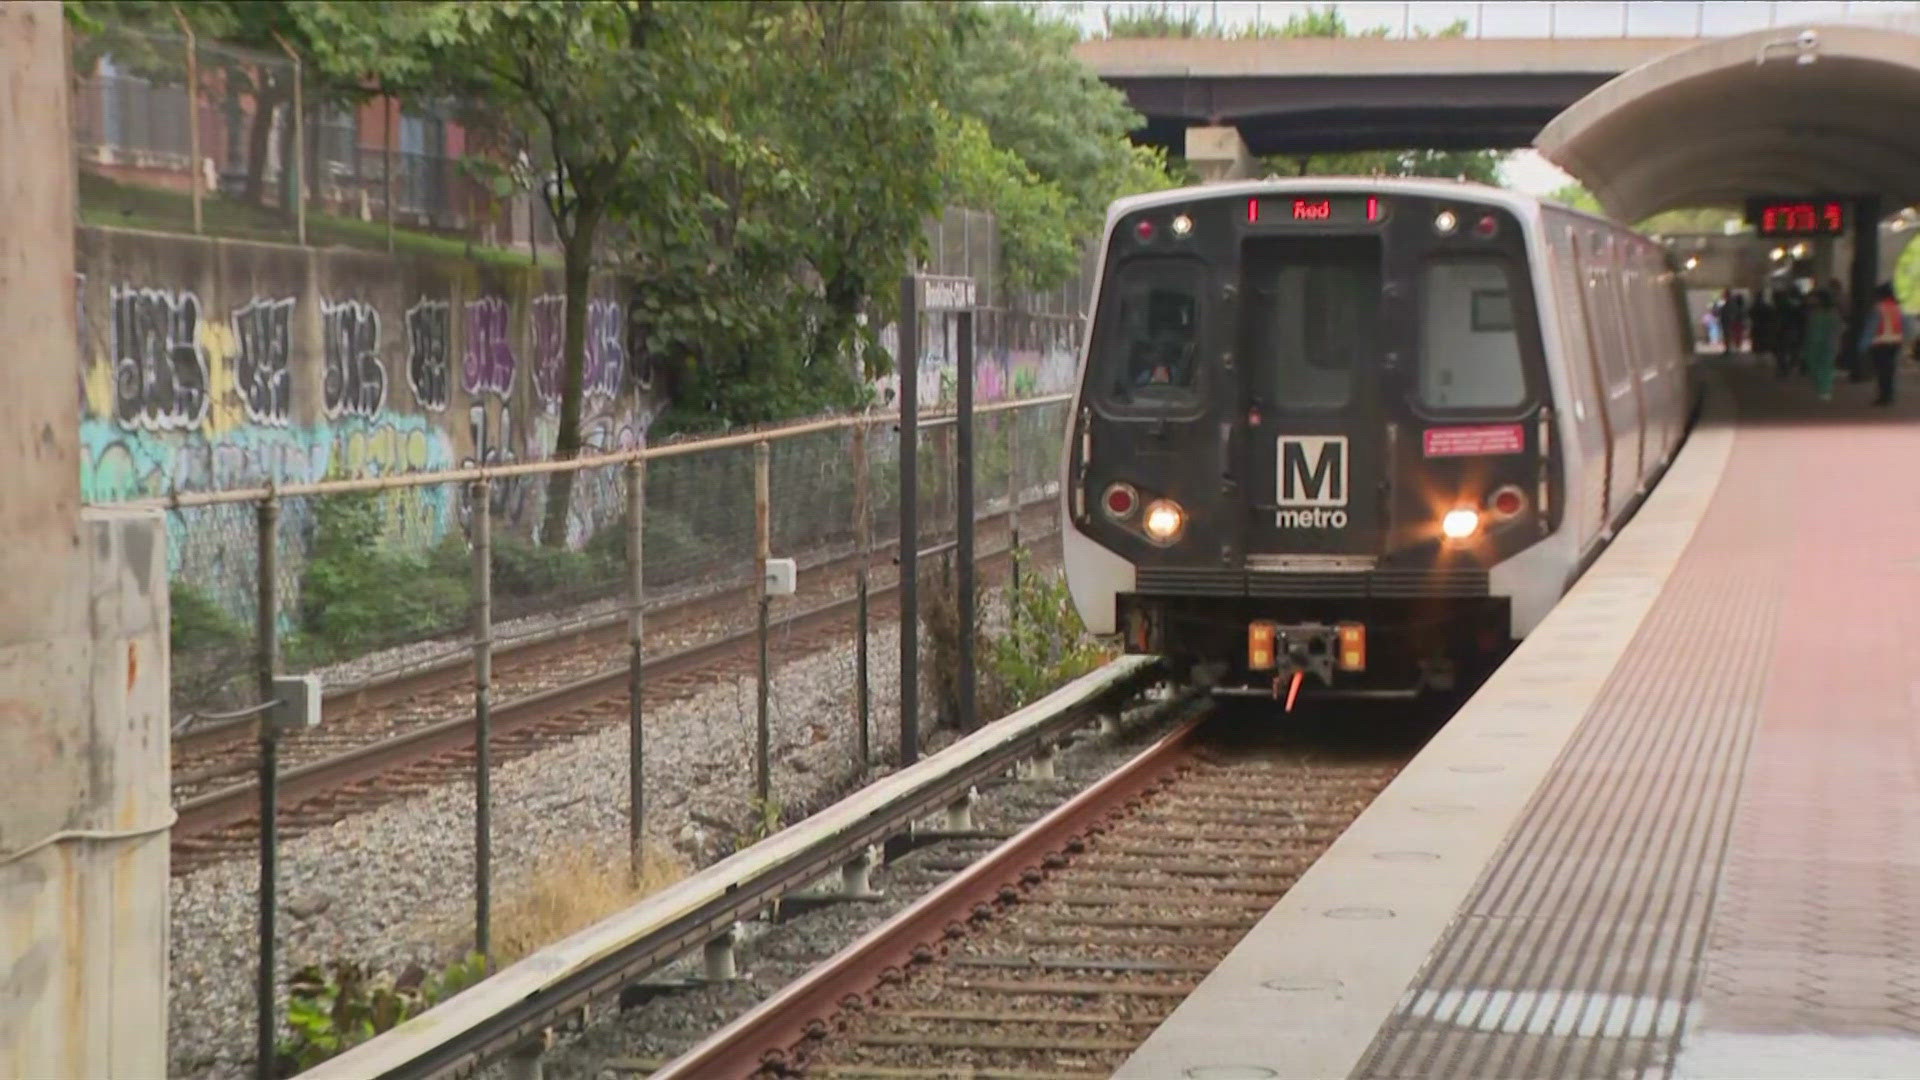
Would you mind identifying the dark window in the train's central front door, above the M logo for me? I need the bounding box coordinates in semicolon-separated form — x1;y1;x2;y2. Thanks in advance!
1244;236;1380;411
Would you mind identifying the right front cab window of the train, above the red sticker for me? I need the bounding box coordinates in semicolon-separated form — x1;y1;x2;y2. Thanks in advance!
1419;258;1526;409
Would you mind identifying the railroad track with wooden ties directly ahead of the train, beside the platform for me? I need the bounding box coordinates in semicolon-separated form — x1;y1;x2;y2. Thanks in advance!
652;713;1415;1080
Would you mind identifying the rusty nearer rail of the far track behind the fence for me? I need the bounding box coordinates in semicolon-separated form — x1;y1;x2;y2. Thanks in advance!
173;530;1059;840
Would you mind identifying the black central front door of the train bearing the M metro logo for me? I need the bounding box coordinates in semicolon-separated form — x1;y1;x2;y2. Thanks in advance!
1236;234;1390;553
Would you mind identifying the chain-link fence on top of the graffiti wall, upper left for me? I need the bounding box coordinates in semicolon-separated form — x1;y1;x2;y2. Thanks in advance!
73;8;557;250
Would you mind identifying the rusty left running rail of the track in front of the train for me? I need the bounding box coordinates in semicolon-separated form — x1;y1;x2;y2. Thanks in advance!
649;713;1206;1080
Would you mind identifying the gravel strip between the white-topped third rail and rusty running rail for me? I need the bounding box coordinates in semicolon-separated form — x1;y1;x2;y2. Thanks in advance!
526;691;1175;1080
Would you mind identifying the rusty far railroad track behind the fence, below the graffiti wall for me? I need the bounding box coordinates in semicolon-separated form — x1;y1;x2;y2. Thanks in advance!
171;530;1052;874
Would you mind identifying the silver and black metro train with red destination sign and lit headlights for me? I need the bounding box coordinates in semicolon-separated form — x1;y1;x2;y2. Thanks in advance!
1060;177;1697;709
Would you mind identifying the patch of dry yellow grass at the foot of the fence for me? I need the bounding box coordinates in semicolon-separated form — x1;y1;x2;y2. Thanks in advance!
493;846;687;965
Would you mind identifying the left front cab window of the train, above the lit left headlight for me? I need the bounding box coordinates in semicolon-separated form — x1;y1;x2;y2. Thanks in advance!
1100;259;1204;407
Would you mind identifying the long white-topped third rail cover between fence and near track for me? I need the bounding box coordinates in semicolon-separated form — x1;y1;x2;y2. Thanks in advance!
301;655;1160;1080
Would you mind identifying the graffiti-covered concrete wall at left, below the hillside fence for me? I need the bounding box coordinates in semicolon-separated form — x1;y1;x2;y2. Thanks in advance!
75;227;657;611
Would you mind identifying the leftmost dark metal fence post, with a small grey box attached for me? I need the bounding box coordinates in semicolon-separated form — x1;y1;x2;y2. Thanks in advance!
253;492;280;1080
